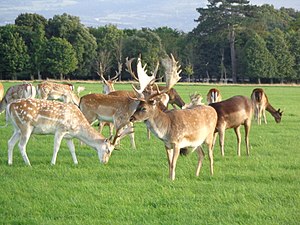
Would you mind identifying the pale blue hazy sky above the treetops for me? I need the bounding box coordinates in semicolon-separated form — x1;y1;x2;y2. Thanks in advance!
0;0;300;32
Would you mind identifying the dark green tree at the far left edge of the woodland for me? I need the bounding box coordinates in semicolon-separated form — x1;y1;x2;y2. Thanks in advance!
0;25;29;80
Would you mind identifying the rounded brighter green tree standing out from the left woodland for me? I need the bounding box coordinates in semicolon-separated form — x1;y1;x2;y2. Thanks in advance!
44;37;78;80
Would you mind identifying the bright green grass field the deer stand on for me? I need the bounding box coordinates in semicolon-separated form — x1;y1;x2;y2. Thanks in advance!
0;83;300;225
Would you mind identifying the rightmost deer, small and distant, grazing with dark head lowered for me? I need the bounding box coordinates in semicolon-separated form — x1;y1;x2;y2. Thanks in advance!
251;88;283;125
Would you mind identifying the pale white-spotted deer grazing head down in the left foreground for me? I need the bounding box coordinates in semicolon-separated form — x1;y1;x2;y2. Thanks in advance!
7;99;131;165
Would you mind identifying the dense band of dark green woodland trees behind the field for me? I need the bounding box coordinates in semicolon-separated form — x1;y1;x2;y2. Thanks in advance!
0;0;300;83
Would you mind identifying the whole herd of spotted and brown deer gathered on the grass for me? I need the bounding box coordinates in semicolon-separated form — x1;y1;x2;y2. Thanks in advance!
0;55;282;180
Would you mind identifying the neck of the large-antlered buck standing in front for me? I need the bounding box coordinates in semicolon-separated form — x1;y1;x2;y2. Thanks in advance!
145;108;171;140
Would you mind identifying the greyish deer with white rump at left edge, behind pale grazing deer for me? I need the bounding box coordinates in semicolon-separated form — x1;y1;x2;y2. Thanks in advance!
0;83;36;113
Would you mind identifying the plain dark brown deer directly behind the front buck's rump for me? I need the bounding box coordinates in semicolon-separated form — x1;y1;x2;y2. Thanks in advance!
210;96;253;156
